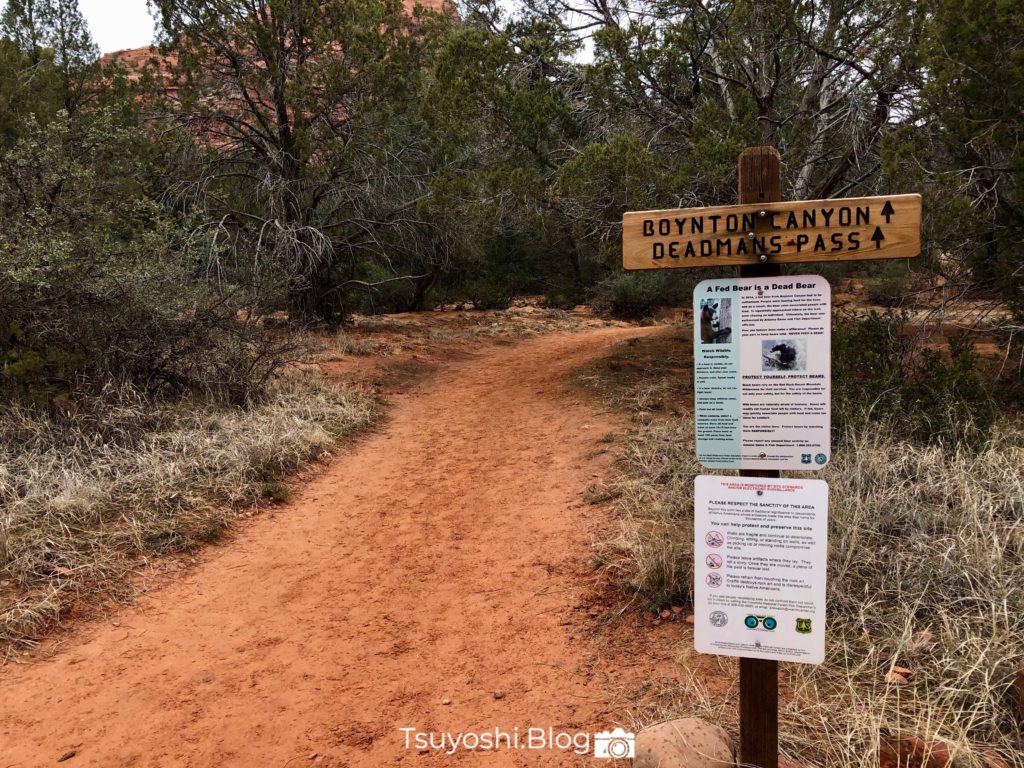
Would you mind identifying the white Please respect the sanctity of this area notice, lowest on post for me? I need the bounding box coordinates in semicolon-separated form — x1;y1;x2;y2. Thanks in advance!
693;475;828;664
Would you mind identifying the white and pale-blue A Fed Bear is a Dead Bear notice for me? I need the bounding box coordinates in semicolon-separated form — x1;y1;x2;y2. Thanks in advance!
693;275;831;470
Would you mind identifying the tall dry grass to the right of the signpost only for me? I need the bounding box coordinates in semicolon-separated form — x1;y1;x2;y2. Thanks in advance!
783;424;1024;767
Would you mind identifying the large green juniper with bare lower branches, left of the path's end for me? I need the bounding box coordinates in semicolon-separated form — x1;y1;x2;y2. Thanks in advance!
152;0;454;321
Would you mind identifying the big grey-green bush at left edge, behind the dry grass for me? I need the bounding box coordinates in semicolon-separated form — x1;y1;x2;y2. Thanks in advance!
0;113;292;402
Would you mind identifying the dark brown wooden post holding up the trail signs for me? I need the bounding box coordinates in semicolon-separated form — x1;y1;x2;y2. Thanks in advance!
738;146;782;768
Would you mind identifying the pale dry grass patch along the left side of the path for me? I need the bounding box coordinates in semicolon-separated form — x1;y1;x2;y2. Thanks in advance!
0;375;377;648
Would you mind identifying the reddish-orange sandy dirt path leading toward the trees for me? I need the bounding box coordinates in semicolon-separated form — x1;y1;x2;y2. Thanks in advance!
0;329;642;768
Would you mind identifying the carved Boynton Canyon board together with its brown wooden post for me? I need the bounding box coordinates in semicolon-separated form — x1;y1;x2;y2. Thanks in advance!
623;146;921;768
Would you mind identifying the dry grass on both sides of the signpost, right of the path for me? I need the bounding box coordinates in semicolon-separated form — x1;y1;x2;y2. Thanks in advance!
587;333;1024;768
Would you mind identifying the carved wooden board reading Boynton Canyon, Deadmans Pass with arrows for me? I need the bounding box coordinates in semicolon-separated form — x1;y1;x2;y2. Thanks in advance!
623;195;921;269
